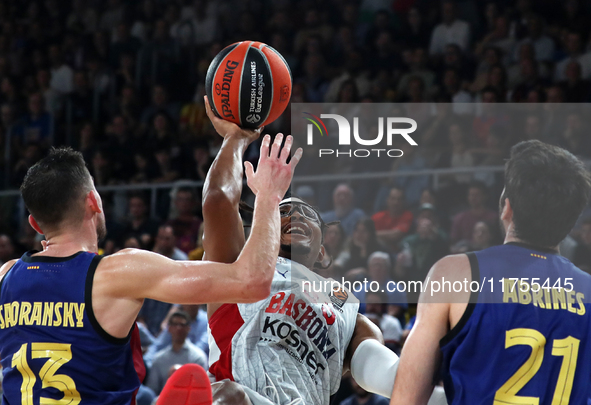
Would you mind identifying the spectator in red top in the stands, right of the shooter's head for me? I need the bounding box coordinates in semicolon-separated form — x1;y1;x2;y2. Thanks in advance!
371;187;413;251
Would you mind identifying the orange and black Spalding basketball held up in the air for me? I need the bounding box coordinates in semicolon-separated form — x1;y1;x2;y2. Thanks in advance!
205;41;291;128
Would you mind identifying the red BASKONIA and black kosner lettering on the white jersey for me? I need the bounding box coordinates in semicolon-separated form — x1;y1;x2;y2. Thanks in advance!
262;292;337;375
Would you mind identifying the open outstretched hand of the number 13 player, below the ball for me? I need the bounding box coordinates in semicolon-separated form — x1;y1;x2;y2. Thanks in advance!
244;134;303;198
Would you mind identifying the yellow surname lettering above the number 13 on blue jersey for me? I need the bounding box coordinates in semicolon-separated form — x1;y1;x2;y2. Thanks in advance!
0;301;85;329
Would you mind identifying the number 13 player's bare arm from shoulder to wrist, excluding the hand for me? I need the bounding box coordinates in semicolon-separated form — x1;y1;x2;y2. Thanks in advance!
92;191;280;337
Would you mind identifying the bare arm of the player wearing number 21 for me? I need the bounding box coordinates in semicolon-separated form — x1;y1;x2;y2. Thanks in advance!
390;255;471;405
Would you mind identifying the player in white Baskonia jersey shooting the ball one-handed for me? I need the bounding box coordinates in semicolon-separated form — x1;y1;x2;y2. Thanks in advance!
203;95;398;405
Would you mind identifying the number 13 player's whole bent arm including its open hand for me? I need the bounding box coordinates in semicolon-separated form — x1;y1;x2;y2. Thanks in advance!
93;136;302;304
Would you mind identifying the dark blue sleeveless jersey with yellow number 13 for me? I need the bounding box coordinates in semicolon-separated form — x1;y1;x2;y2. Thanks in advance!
0;252;140;405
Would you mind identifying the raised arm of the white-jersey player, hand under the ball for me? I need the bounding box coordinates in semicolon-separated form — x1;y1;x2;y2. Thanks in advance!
203;97;262;263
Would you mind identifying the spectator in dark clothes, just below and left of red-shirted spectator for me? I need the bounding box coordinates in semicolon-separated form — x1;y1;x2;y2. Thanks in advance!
335;218;386;271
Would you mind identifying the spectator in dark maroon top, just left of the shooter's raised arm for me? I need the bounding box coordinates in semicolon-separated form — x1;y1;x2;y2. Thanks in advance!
166;187;202;254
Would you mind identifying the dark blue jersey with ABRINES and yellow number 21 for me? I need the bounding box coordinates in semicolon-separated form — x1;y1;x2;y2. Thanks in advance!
441;243;591;405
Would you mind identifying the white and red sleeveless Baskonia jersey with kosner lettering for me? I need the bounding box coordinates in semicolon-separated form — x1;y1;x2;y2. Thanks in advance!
209;257;359;405
